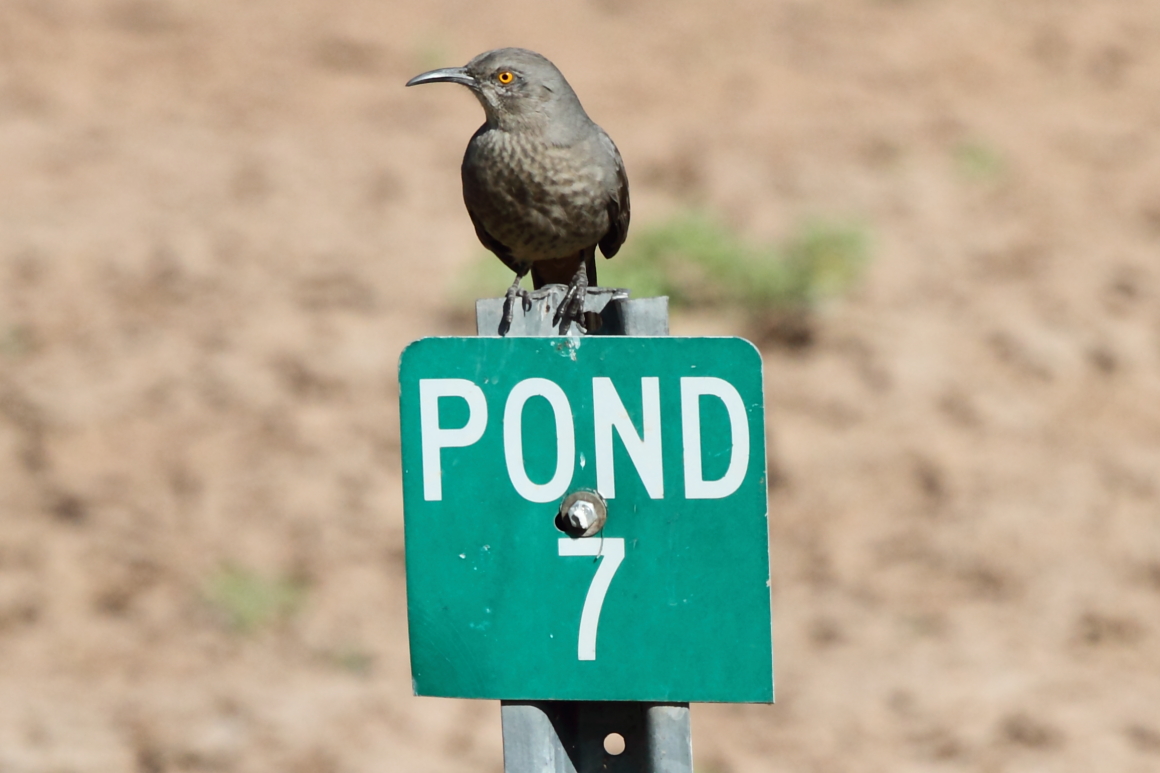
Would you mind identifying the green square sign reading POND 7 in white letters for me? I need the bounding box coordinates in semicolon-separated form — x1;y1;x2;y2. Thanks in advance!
399;337;774;702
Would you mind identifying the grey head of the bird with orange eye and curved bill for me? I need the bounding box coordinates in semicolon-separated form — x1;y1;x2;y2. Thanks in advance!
407;49;588;135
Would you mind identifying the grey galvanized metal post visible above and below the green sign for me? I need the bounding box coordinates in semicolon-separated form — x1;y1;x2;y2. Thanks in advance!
476;284;693;773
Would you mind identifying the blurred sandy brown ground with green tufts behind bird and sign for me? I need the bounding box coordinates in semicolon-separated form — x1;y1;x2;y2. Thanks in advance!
0;0;1160;773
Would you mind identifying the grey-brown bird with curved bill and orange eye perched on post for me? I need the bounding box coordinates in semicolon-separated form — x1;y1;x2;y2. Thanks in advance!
406;48;630;335
